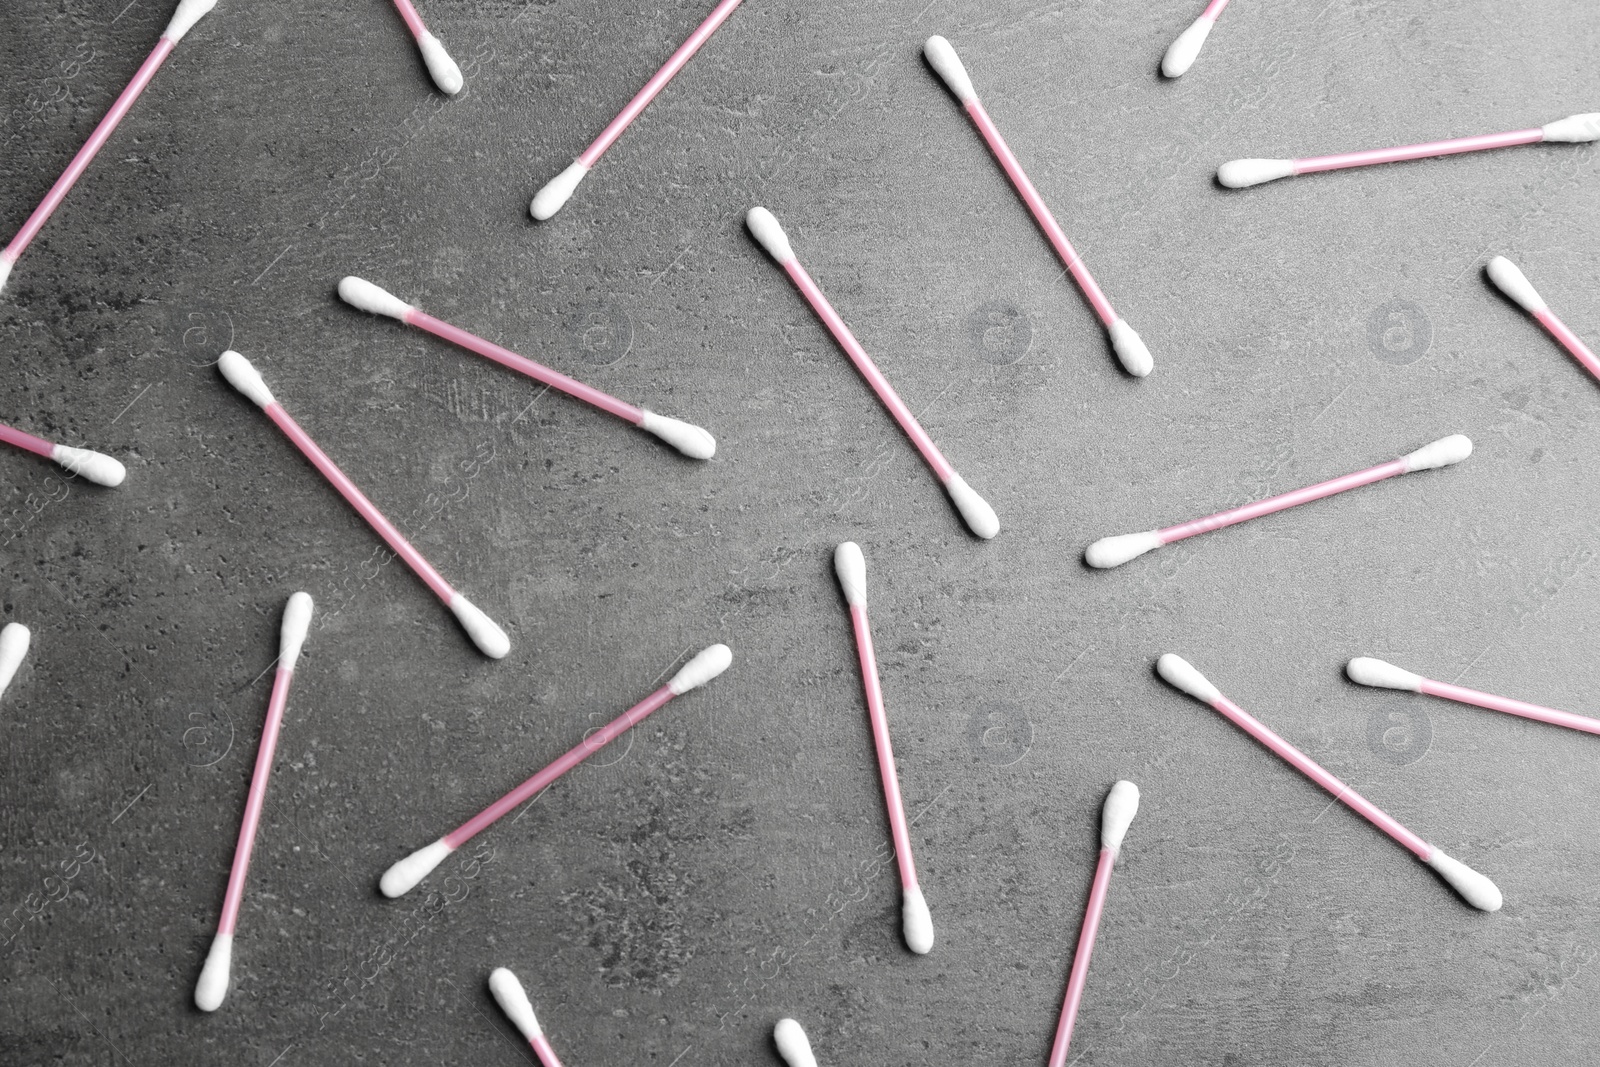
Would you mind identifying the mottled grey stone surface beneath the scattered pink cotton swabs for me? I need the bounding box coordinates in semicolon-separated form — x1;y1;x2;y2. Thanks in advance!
0;0;1600;1067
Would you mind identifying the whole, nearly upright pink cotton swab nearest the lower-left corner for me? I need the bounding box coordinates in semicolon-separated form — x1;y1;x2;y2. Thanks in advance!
195;593;312;1011
